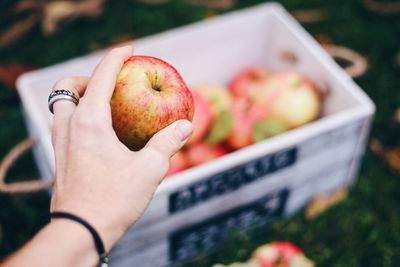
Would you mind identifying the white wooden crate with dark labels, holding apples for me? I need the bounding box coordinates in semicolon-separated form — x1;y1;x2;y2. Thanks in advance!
17;3;374;266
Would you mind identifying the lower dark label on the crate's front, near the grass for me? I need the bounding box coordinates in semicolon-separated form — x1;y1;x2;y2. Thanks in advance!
169;188;289;262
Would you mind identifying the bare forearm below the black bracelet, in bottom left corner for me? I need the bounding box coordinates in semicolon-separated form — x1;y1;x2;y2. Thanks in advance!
2;219;99;267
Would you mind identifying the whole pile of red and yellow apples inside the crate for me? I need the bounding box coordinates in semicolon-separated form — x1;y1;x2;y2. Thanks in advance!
168;67;321;175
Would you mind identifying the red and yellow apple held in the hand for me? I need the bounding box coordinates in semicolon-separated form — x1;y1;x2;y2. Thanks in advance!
110;56;194;150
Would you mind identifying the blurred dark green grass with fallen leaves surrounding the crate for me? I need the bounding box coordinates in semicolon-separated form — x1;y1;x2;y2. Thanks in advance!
0;0;400;267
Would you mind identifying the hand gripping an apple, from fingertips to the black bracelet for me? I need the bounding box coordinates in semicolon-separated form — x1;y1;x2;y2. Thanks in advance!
51;47;192;251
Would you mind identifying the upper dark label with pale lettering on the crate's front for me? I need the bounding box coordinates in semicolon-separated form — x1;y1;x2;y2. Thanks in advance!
169;148;297;213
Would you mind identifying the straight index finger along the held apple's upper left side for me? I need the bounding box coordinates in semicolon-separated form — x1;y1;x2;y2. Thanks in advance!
82;46;133;110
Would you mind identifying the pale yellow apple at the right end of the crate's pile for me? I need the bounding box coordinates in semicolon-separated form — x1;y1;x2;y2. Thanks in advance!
251;72;321;128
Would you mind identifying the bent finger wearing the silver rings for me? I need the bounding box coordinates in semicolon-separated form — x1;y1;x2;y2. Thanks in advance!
52;77;89;178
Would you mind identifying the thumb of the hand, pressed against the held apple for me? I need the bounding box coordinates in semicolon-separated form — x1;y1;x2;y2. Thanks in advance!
143;120;193;159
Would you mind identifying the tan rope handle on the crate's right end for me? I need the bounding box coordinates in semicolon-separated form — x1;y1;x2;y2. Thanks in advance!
323;45;368;78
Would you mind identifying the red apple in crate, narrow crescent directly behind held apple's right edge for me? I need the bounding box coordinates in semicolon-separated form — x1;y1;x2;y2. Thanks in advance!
187;90;214;145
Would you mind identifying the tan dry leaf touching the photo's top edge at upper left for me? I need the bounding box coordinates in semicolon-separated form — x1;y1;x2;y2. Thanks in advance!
42;0;104;35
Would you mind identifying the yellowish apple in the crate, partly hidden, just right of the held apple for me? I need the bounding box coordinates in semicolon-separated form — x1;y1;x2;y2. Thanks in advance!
197;85;232;116
